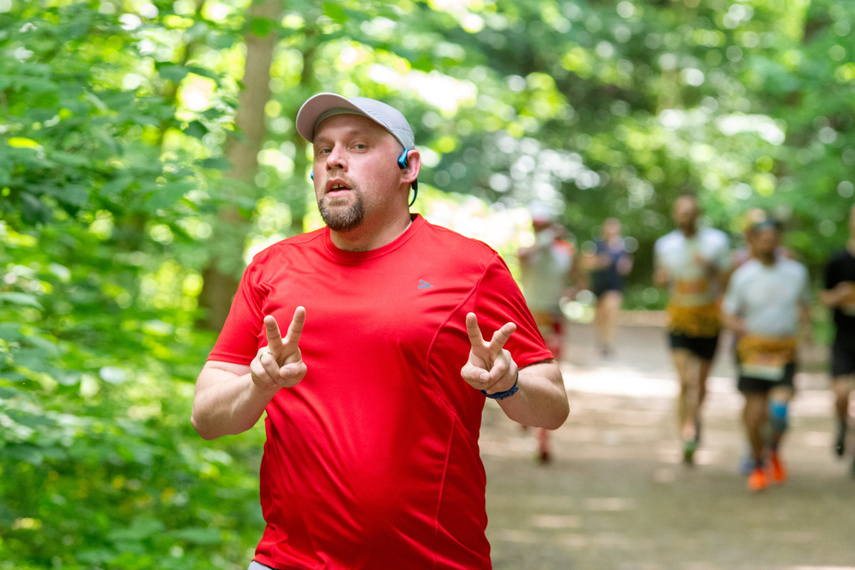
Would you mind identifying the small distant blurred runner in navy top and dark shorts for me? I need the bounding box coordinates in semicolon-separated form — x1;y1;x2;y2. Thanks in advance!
587;218;632;358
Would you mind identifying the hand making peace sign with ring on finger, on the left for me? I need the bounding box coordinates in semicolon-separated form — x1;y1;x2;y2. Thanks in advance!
249;307;306;389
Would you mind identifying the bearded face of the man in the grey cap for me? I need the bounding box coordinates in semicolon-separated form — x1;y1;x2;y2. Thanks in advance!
313;115;406;232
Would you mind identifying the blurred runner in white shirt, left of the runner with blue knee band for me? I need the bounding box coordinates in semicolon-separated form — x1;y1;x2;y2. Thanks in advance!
653;194;731;465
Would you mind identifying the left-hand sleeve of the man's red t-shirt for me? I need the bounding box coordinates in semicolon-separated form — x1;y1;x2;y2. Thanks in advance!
208;258;264;364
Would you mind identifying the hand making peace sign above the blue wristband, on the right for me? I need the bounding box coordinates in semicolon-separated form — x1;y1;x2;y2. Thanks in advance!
460;313;518;394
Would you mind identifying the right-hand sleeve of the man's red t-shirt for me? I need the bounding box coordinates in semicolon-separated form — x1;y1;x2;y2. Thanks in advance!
475;254;553;367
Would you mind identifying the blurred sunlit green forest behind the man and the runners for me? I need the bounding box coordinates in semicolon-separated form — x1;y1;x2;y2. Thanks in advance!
0;0;855;570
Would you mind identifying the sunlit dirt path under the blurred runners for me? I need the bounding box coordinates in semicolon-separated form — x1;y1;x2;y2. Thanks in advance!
481;325;855;570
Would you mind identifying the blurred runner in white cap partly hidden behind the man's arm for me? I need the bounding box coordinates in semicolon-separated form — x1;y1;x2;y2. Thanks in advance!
517;203;579;464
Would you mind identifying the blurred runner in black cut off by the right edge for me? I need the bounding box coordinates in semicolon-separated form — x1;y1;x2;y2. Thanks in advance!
819;202;855;475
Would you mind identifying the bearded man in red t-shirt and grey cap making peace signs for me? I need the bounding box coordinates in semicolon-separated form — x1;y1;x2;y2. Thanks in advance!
192;93;569;570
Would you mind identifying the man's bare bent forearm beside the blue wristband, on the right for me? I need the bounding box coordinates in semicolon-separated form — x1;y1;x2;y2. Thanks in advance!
498;361;570;429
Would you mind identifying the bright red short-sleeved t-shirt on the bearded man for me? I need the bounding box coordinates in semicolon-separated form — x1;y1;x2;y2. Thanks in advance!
209;216;552;570
